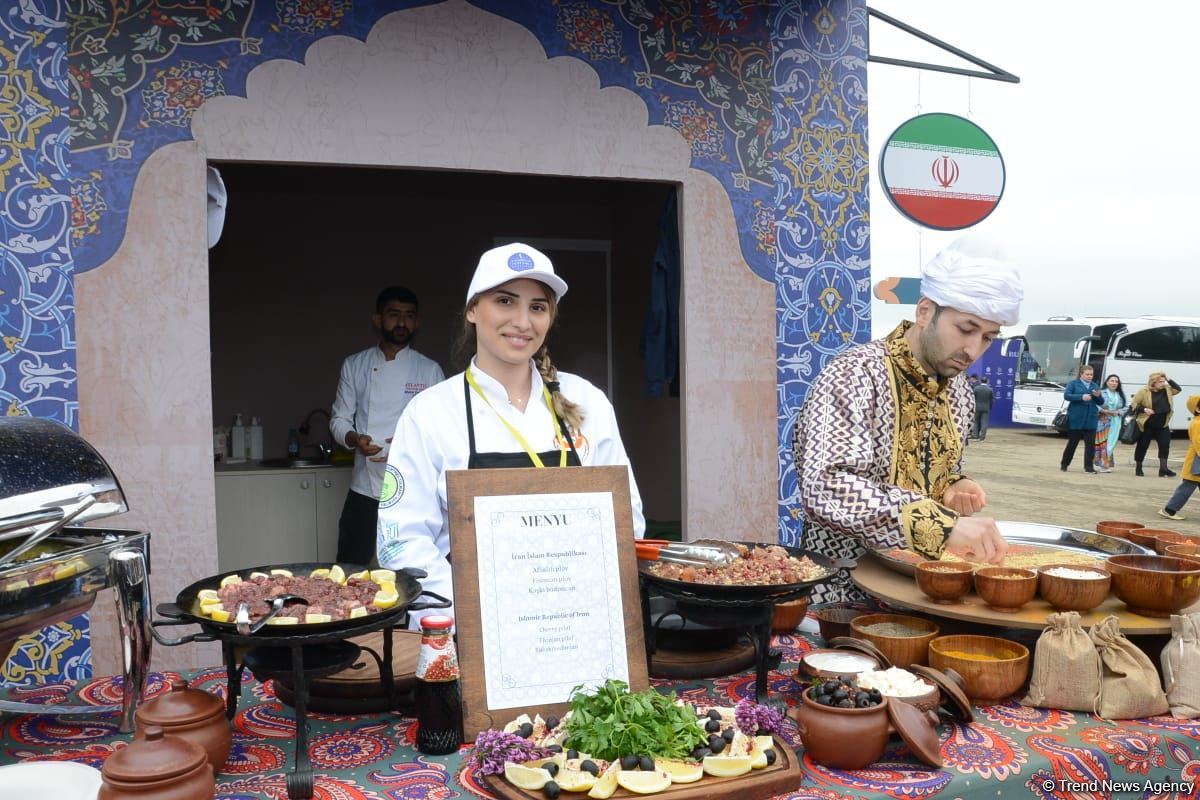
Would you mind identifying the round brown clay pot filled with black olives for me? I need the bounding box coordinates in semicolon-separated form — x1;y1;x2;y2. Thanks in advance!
790;688;889;770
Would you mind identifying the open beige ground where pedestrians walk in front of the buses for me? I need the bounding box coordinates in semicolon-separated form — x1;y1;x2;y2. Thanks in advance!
962;427;1200;535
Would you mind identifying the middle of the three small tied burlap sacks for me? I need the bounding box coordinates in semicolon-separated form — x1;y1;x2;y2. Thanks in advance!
1091;616;1169;720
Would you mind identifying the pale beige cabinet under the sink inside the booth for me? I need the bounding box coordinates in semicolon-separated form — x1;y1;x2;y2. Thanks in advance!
216;467;350;572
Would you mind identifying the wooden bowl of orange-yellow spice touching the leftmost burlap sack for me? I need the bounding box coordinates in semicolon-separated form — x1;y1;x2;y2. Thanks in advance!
929;634;1030;700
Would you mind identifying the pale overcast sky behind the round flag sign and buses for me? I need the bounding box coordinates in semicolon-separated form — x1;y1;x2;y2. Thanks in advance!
868;0;1200;336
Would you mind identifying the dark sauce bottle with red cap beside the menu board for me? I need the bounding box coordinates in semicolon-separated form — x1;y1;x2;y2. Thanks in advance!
415;614;462;756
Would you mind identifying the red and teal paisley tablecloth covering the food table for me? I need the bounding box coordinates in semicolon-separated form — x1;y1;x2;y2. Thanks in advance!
0;633;1200;800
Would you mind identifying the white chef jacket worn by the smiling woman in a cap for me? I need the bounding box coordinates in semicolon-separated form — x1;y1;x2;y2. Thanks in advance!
376;361;646;628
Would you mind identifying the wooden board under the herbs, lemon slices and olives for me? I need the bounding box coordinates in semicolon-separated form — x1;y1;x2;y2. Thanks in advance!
480;736;804;800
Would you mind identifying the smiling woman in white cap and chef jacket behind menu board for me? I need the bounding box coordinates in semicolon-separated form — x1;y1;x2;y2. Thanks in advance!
376;243;646;627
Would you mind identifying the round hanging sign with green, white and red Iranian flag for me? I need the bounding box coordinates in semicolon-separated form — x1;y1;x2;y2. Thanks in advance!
880;114;1004;230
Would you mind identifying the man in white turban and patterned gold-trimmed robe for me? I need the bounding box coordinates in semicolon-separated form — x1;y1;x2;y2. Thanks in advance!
792;237;1024;602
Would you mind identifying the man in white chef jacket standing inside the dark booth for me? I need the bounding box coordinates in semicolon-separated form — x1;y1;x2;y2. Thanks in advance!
329;287;445;564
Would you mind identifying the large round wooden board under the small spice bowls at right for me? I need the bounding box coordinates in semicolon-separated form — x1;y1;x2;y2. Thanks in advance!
850;558;1200;636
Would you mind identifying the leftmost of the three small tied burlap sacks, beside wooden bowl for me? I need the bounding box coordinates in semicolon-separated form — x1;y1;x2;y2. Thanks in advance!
1021;612;1100;714
